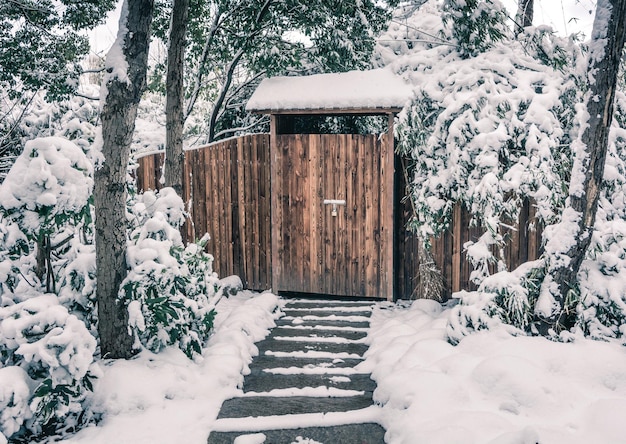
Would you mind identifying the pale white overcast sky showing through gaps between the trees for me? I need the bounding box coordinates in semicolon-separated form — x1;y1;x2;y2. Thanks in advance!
91;0;596;56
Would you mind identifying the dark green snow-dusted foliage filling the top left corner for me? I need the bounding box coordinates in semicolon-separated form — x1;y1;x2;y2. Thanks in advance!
0;0;115;99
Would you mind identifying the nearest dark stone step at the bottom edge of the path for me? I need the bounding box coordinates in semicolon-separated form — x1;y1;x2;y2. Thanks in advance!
208;423;385;444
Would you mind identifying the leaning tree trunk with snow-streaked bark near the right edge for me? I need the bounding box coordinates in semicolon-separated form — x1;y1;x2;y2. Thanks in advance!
537;0;626;333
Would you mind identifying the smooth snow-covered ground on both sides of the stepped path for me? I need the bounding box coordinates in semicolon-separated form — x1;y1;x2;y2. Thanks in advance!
52;292;626;444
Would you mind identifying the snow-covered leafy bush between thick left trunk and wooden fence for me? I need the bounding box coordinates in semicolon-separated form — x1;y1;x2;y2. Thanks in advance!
121;188;218;358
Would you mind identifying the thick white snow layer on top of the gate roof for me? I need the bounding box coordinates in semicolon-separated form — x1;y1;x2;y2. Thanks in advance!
246;69;411;111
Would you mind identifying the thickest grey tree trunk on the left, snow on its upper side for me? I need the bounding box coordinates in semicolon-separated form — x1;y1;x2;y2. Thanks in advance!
94;0;153;358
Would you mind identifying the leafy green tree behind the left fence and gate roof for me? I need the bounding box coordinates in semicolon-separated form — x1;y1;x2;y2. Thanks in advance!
155;0;398;141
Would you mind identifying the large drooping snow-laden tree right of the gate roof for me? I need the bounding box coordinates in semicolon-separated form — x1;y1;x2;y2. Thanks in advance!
394;2;579;284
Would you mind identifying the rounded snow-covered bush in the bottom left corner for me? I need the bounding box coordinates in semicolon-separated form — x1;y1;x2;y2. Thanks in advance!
0;292;99;440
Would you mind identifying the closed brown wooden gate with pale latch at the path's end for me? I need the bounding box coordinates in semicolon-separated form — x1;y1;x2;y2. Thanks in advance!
272;134;393;298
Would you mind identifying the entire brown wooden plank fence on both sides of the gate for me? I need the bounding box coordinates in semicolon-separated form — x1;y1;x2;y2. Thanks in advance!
137;134;541;298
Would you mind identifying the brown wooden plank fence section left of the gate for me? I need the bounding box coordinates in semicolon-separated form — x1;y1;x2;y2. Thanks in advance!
136;134;272;290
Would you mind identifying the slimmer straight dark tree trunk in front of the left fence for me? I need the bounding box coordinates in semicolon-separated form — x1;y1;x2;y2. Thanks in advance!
163;0;189;197
